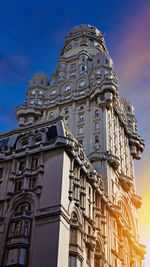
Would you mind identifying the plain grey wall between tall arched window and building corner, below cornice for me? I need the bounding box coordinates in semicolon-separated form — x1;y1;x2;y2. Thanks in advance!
29;219;60;267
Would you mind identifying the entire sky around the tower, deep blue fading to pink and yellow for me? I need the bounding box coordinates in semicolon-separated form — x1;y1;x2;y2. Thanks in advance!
0;0;150;267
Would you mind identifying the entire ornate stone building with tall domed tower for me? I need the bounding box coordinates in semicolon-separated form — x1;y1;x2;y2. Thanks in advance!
0;25;145;267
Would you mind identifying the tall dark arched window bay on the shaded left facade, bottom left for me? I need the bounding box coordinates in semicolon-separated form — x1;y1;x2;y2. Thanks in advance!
3;202;32;267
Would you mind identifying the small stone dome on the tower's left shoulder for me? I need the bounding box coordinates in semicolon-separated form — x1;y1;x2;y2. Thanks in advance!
29;71;49;87
